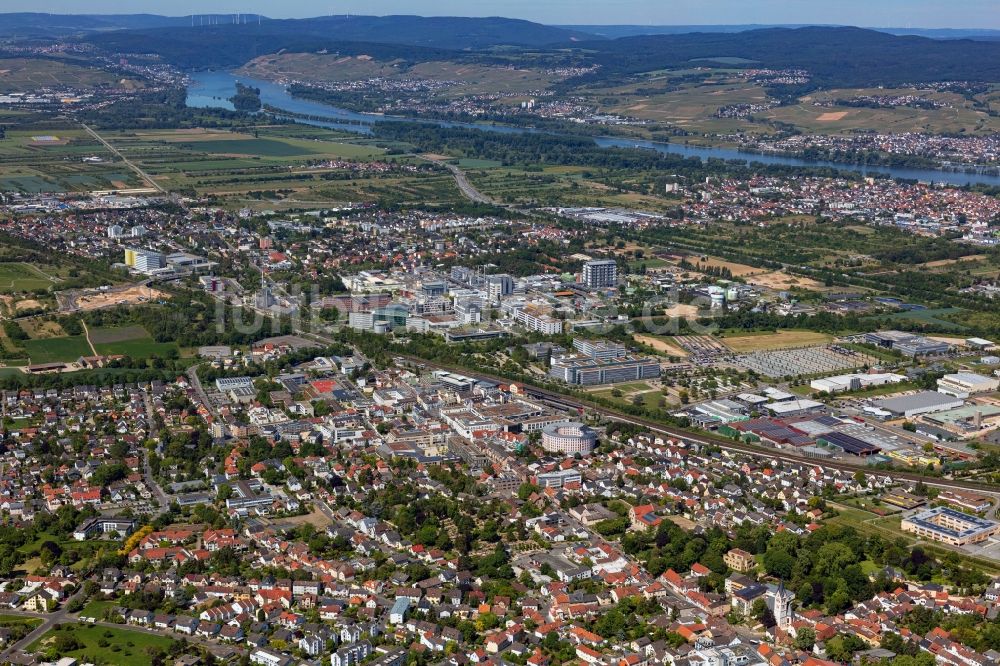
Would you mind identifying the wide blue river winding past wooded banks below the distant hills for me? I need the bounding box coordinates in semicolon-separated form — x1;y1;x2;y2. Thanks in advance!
187;72;1000;185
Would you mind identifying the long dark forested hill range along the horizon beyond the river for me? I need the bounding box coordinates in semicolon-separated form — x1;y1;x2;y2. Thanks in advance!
58;16;1000;87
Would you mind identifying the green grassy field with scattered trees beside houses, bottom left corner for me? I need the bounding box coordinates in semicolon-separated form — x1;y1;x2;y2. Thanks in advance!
28;624;173;666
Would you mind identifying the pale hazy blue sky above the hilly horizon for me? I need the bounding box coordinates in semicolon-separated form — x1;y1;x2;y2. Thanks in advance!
0;0;1000;28
